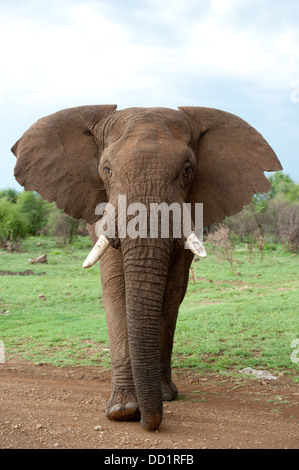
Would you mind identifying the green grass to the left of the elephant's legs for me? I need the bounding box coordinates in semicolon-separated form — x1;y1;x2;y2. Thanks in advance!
0;238;109;365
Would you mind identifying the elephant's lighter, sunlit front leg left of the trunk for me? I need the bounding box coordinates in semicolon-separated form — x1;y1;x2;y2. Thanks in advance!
101;248;140;421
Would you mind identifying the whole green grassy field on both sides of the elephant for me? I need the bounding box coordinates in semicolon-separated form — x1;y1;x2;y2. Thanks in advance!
0;238;299;376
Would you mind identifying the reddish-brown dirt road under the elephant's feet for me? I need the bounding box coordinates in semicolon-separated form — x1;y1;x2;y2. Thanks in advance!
0;360;299;449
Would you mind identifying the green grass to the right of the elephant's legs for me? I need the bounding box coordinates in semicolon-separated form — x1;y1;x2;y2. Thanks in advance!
173;247;299;371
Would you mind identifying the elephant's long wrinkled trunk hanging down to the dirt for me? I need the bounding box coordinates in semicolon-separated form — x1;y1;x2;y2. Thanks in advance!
122;239;171;430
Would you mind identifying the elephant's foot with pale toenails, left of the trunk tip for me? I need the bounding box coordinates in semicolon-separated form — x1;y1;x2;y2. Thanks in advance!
105;390;140;421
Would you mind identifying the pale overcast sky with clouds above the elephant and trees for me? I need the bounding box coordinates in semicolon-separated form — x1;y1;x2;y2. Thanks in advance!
0;0;299;189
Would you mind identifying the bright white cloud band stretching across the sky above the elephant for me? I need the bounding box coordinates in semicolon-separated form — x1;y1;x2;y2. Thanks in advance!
0;0;299;110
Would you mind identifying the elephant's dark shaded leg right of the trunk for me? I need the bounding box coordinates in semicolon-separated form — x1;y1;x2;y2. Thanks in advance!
159;249;193;401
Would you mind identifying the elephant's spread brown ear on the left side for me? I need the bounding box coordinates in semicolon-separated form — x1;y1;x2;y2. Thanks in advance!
11;105;116;224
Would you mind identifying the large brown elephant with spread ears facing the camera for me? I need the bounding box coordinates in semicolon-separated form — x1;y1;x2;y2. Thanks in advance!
11;105;282;431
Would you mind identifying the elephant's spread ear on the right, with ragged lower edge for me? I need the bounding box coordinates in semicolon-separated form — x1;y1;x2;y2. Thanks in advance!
178;106;282;226
